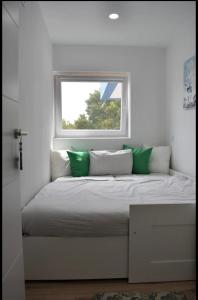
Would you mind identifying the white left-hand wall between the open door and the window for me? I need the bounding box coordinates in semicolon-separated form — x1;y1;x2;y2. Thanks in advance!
19;1;53;205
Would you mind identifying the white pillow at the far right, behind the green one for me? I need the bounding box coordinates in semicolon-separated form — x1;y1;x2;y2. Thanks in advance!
144;145;171;174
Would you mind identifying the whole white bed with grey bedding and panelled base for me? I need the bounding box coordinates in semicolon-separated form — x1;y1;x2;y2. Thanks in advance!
22;171;195;282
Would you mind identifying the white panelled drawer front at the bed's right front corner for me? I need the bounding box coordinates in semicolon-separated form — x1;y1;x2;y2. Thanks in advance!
129;203;195;283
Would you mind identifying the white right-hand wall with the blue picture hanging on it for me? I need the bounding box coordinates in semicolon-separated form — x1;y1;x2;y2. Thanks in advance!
166;4;196;176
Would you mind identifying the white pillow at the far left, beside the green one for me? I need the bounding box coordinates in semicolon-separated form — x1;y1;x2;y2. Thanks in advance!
51;150;71;180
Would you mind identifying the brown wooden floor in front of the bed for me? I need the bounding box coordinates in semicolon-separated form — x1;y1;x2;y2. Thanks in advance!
26;279;196;300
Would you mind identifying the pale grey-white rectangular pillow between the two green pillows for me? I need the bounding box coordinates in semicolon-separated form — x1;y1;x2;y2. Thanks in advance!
89;149;133;175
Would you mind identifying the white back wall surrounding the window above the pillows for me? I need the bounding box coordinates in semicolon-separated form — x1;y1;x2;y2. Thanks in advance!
53;45;166;149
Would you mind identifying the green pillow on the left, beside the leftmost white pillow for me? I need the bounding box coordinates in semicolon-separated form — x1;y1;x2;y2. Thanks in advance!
67;151;89;177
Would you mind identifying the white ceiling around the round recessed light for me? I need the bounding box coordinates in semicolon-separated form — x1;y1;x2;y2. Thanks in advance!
39;1;195;47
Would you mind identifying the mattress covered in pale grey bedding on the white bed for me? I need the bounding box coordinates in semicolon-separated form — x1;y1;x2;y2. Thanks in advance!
22;174;195;237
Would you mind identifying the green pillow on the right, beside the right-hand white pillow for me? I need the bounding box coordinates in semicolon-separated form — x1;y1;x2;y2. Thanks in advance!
123;145;152;174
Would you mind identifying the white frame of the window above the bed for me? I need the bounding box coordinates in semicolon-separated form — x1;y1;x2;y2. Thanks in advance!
54;72;130;139
